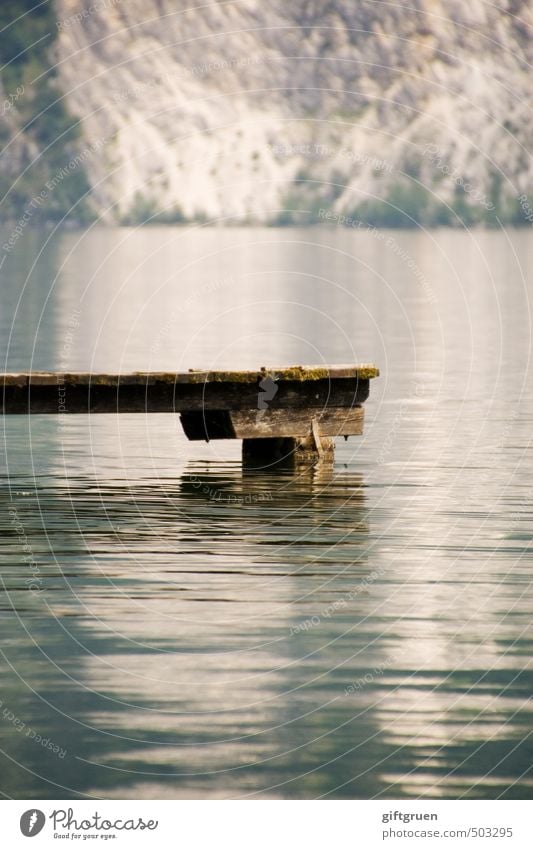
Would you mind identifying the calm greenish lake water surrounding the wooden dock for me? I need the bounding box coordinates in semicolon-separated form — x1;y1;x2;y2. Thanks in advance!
0;227;533;799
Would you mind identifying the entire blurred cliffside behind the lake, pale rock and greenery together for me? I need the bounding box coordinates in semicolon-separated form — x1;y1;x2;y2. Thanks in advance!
0;0;533;227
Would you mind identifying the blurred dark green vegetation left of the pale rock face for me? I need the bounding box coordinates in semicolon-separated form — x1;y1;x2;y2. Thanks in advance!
0;0;90;223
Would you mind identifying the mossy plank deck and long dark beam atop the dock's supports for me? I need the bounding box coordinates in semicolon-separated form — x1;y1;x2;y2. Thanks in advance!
0;366;378;414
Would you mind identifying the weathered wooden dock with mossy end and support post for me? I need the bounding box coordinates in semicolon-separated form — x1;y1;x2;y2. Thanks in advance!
0;365;379;465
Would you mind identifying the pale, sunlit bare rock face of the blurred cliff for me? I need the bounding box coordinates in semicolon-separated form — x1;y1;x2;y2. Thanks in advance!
55;0;533;223
